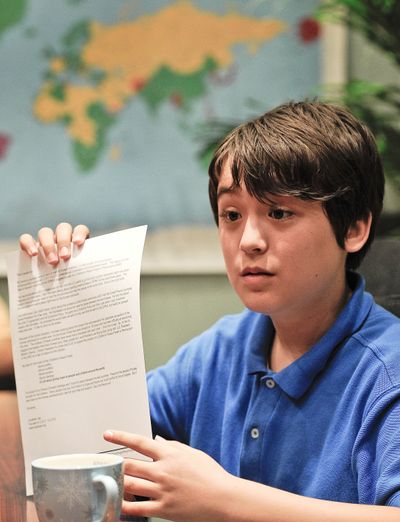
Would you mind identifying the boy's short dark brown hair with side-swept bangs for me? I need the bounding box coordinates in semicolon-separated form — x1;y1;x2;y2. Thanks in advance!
209;102;384;269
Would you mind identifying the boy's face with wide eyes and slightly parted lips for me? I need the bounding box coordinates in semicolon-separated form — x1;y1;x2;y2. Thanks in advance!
218;162;346;319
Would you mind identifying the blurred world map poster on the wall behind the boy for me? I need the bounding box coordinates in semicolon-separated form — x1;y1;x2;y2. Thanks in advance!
0;0;320;239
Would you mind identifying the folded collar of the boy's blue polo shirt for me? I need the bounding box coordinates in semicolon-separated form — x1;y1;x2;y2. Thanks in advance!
248;272;373;399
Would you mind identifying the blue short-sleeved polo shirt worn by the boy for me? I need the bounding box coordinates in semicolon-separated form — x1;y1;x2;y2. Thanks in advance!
148;274;400;506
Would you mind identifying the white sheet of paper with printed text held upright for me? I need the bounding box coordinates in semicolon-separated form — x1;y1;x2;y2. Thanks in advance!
7;226;151;495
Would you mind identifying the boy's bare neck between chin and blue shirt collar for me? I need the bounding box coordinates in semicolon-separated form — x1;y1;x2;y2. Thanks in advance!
268;284;352;372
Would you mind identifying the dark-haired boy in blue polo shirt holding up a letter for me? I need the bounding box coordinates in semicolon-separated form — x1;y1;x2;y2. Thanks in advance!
21;102;400;522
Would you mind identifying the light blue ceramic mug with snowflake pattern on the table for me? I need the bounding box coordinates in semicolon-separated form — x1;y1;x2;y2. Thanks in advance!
32;453;124;522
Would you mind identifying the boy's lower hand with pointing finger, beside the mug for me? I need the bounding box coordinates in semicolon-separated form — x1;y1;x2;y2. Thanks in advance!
104;431;234;522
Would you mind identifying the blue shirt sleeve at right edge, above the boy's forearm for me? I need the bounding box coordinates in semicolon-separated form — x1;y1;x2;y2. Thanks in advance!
353;386;400;507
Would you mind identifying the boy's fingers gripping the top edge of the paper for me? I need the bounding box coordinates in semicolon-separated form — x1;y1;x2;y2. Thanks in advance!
19;223;89;265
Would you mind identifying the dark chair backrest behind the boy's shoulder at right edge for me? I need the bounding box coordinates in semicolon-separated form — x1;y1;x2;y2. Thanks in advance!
359;238;400;317
